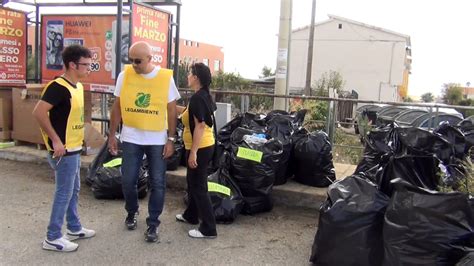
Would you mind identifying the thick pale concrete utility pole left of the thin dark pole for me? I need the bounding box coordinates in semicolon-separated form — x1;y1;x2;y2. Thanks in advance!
273;0;293;111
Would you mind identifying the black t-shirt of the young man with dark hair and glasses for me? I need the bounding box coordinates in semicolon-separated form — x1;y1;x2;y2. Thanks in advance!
41;78;76;151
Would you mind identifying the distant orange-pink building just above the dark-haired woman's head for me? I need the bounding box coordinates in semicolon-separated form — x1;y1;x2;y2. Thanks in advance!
172;39;224;75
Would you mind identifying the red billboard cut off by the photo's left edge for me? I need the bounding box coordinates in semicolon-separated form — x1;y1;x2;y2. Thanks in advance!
0;7;28;86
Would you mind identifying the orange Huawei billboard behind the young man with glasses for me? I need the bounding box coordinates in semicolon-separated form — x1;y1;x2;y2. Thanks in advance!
41;15;128;92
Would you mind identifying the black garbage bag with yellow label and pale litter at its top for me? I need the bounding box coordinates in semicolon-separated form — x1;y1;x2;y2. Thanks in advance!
230;128;283;214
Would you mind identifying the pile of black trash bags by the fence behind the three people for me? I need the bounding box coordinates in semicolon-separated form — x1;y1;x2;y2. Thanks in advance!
87;110;336;223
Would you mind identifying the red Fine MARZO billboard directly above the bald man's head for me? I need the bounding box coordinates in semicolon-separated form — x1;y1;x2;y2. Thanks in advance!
131;3;171;68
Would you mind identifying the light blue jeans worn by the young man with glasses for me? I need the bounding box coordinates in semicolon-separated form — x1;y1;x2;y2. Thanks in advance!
46;154;82;241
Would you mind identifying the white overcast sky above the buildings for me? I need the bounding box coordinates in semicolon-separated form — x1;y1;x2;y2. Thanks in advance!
7;0;474;95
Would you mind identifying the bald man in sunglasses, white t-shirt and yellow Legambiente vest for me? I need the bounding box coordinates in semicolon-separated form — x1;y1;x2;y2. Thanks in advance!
108;42;180;242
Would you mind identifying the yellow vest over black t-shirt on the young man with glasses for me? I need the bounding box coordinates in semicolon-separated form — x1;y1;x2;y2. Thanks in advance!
41;78;84;151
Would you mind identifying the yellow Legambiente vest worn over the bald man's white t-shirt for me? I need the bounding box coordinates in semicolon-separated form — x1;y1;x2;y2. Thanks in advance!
120;65;173;131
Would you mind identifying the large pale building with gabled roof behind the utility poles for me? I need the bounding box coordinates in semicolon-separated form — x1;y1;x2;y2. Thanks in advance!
289;15;411;102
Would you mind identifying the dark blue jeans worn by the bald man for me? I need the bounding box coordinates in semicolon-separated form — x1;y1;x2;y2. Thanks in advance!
122;142;166;227
